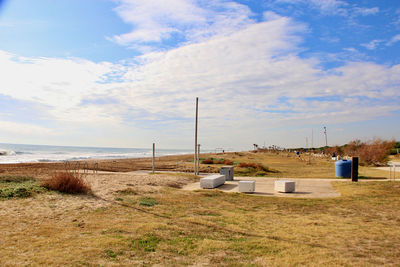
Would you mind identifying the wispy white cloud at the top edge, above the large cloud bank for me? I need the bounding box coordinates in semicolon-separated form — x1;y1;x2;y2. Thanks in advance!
111;0;252;51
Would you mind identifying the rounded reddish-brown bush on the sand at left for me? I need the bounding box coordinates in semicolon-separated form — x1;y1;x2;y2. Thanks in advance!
42;172;91;194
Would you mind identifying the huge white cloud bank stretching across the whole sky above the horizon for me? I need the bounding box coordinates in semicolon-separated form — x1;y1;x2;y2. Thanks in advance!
0;10;400;147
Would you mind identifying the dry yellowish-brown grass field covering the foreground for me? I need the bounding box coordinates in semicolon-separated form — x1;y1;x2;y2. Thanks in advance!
0;154;400;266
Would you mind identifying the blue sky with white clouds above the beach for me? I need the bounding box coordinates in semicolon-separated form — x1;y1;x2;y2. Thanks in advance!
0;0;400;150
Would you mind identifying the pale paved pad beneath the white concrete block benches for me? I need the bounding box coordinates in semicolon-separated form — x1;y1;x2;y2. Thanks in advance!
183;177;342;198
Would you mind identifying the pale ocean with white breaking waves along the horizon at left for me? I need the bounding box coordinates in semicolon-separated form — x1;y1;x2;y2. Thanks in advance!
0;143;193;164
